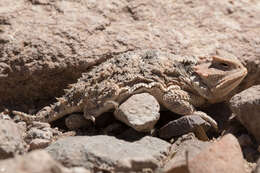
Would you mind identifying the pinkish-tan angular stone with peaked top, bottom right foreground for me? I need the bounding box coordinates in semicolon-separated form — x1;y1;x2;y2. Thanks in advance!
164;134;245;173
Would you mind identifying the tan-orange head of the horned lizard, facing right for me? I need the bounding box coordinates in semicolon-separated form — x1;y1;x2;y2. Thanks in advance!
193;56;247;103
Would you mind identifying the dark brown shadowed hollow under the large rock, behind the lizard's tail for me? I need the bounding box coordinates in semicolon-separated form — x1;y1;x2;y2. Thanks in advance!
0;49;136;112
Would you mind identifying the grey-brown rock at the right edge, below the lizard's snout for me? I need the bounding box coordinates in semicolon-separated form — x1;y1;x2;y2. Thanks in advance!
230;85;260;142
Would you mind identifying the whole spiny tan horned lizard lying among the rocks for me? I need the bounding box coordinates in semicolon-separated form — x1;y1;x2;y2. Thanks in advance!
13;50;247;130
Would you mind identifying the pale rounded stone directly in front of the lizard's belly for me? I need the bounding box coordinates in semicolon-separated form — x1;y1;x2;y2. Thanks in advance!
114;93;160;132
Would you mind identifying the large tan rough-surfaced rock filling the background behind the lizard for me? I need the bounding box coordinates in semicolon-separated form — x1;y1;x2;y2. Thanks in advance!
0;0;260;110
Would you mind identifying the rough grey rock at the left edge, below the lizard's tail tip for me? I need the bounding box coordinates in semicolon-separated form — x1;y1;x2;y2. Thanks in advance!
0;120;27;159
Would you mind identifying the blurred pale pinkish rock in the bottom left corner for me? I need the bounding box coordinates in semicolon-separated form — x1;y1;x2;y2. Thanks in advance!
0;150;70;173
